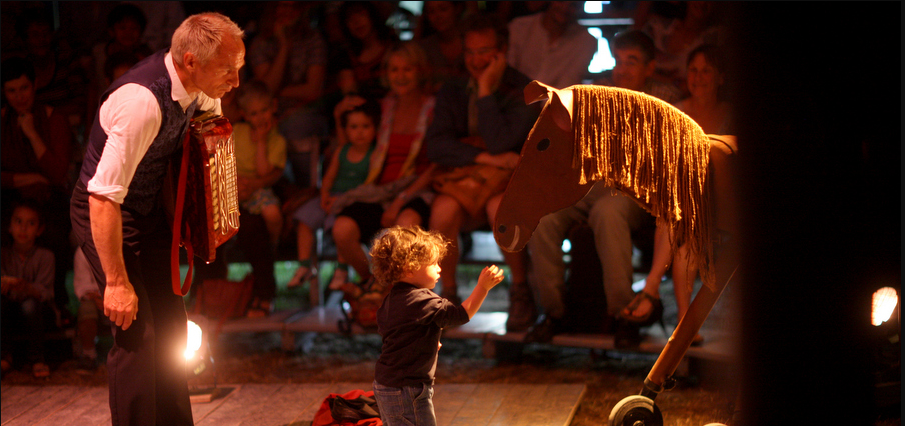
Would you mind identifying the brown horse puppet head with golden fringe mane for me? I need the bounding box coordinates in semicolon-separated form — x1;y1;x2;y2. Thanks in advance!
493;81;722;290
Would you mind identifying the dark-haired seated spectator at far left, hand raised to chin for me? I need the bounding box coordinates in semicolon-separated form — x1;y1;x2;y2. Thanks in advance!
0;57;73;316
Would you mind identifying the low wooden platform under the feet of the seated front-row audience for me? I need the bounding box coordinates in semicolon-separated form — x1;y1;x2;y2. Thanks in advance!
208;306;735;362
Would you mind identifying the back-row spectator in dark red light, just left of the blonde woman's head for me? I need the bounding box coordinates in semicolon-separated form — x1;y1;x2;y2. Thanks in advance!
337;1;398;100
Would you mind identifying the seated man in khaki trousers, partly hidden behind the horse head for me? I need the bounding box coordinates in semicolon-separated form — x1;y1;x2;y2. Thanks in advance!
525;30;677;347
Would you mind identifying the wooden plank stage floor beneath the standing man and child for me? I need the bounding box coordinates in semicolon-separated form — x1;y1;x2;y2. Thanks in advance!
0;383;585;426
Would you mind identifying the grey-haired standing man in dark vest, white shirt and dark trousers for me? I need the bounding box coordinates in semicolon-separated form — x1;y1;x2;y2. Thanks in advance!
71;13;245;425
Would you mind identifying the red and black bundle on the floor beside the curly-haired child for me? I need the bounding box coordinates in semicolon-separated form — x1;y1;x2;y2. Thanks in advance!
311;389;383;426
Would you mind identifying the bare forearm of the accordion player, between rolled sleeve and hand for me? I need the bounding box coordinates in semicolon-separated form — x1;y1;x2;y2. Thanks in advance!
88;195;128;285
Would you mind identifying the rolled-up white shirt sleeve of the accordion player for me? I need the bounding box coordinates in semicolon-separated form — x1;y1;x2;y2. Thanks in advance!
88;83;162;204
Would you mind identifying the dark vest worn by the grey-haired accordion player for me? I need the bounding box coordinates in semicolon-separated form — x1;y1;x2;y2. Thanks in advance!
79;50;196;215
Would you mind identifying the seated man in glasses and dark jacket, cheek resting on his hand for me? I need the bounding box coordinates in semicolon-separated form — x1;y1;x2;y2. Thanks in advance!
425;14;540;329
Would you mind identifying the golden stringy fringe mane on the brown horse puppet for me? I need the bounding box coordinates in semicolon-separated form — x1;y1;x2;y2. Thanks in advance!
572;85;713;288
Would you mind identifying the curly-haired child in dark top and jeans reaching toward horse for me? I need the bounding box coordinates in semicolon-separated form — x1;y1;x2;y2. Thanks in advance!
371;226;503;426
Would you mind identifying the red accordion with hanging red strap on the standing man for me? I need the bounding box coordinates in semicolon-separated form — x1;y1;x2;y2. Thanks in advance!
173;112;239;295
